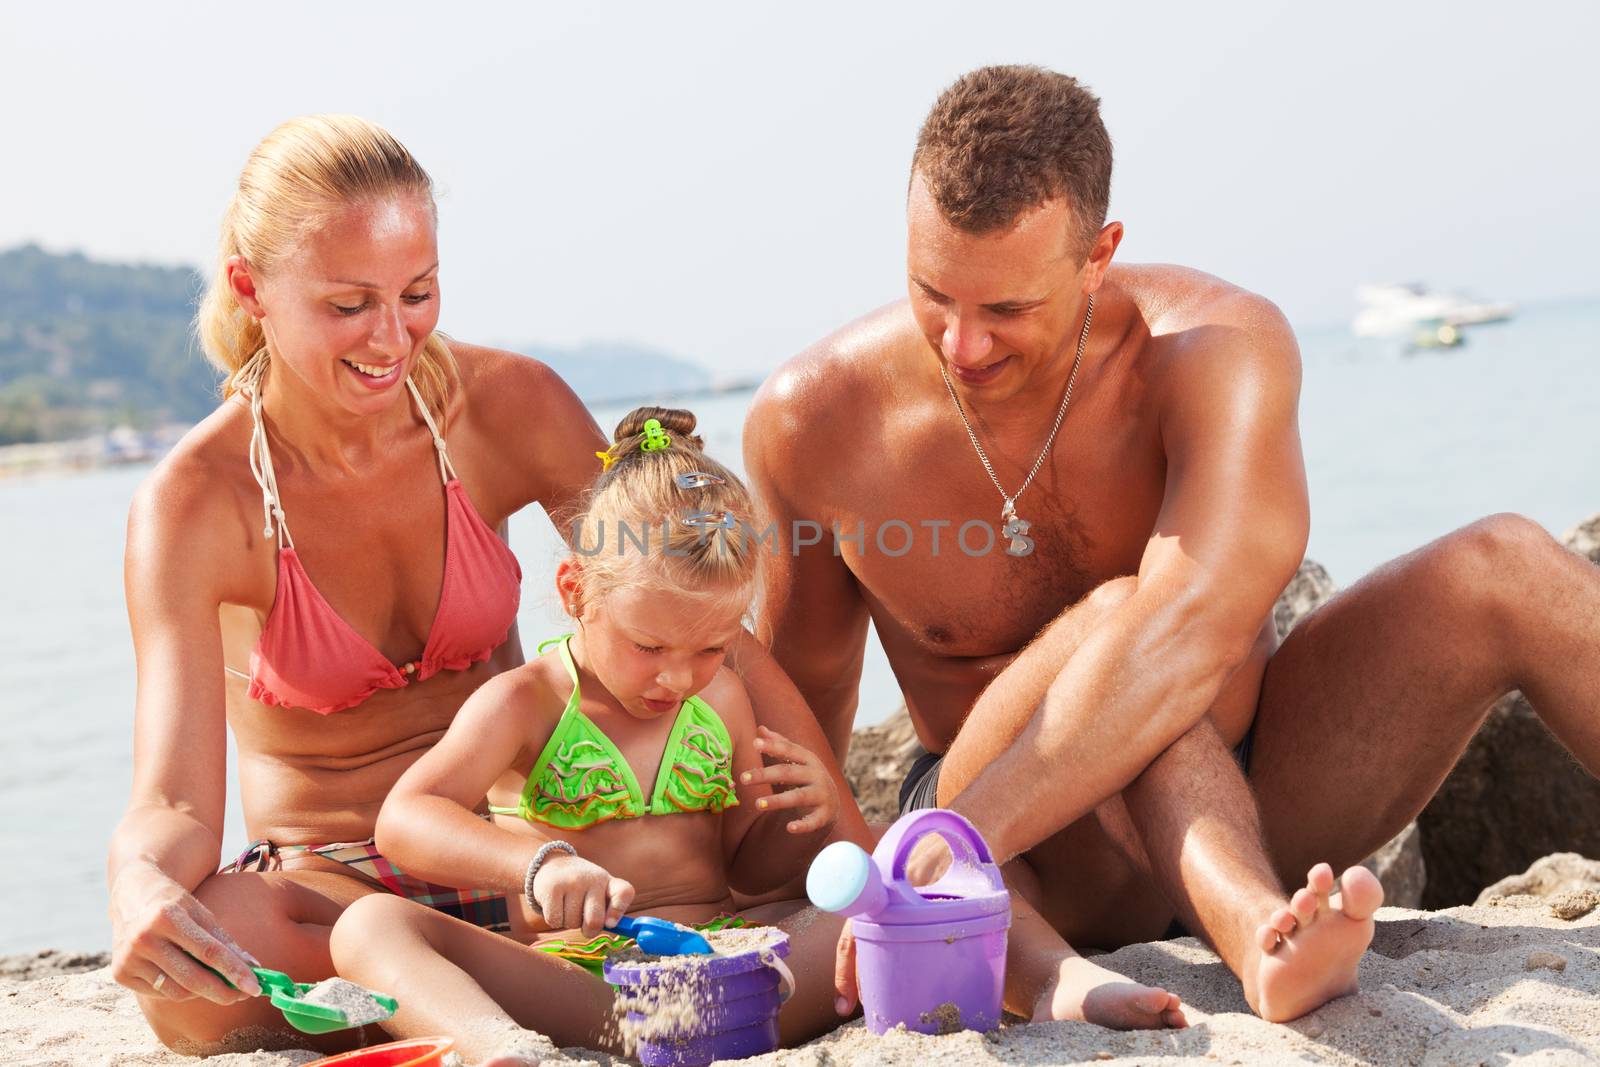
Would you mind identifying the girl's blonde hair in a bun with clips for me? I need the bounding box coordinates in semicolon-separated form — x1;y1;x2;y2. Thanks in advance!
573;408;760;614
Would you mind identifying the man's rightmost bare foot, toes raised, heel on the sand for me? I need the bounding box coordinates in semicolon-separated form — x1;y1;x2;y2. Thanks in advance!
1243;864;1384;1022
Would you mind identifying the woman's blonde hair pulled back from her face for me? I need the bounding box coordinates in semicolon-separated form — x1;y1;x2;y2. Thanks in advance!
195;115;456;419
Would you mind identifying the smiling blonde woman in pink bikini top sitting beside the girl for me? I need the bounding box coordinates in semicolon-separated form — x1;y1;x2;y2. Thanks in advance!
109;115;864;1051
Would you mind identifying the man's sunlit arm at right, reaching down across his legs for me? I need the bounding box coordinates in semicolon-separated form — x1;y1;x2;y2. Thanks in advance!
950;298;1309;859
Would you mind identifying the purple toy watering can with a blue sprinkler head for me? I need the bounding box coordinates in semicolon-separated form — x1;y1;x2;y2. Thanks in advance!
805;808;1011;1033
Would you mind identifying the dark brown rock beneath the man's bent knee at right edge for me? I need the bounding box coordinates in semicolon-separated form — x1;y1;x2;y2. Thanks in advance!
1418;693;1600;909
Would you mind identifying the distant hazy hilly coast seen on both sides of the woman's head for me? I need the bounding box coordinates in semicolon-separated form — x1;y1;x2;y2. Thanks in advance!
0;245;712;445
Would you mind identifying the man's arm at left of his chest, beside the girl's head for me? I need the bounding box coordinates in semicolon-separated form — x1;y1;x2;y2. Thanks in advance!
741;367;869;763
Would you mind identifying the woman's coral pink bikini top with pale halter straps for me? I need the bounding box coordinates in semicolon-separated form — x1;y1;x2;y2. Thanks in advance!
229;373;522;715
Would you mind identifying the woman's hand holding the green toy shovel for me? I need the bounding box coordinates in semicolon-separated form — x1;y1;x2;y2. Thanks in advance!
110;861;261;1005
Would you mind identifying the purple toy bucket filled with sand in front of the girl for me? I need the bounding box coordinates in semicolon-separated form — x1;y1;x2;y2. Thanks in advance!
605;928;792;1067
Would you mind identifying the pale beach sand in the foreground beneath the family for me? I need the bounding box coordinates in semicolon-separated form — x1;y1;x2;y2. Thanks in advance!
12;896;1600;1067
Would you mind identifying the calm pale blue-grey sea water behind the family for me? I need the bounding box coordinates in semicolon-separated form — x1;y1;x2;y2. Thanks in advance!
0;302;1600;952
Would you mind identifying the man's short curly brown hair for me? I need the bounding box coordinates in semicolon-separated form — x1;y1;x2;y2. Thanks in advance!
912;66;1110;254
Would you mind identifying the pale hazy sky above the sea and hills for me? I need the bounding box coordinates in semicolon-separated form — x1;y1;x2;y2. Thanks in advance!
0;0;1600;374
